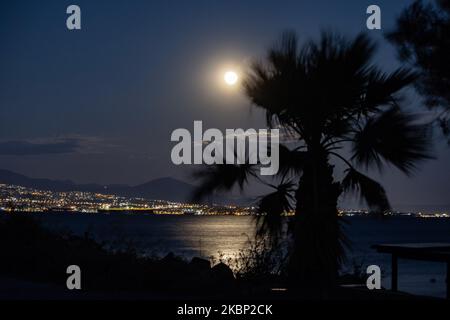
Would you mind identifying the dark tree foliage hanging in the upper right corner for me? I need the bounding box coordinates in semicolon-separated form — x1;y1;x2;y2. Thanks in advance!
387;0;450;140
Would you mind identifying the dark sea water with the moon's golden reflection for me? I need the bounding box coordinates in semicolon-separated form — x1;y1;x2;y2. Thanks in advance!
33;213;450;298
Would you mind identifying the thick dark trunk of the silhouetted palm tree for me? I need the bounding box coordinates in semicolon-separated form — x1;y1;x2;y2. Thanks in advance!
289;153;342;297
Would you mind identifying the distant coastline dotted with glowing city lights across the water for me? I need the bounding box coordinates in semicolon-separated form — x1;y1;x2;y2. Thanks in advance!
0;184;450;219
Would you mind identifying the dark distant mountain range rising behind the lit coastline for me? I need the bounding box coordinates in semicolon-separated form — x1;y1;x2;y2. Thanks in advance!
0;169;250;205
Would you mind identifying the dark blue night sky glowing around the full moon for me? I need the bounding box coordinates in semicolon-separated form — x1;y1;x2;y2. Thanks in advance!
0;0;450;209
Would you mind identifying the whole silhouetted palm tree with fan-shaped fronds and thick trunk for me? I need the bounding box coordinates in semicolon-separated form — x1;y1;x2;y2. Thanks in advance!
192;32;430;292
